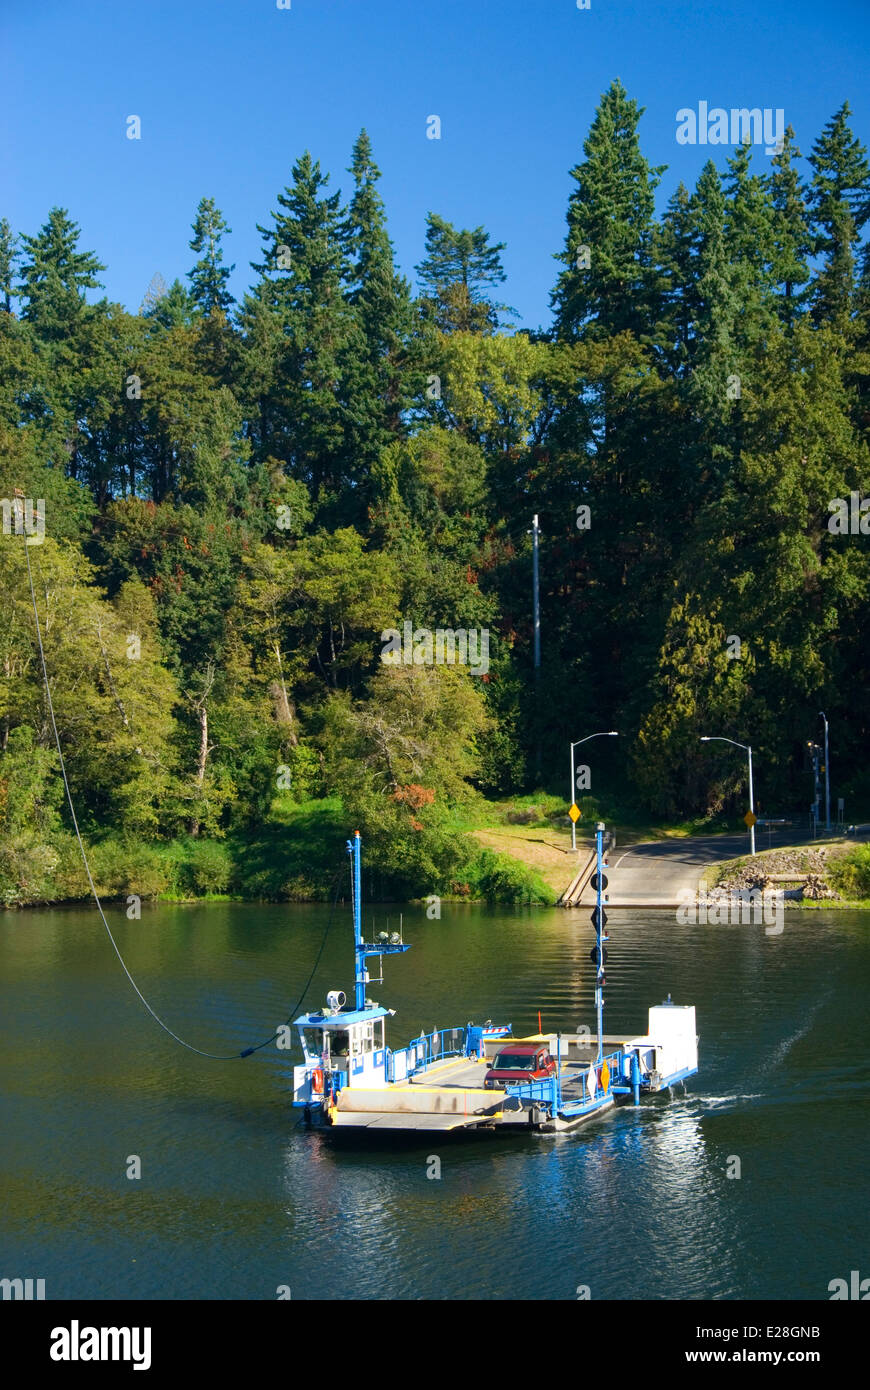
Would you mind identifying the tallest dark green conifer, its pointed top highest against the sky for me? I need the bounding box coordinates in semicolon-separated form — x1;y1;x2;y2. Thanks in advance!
535;81;669;783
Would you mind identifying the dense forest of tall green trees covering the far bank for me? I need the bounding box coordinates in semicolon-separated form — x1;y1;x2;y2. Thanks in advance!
0;81;870;906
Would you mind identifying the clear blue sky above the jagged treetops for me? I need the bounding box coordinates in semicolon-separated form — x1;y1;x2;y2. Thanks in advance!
0;0;870;327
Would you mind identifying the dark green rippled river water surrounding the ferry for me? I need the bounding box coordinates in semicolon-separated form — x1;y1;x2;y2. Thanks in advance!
0;904;870;1300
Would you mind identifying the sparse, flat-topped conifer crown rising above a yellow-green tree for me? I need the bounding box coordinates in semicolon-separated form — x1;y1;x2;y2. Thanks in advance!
414;213;514;334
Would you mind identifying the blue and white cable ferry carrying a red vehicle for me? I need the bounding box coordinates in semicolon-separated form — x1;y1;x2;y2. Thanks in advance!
293;823;698;1134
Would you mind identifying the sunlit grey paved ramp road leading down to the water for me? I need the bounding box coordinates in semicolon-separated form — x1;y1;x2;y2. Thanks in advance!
575;827;863;908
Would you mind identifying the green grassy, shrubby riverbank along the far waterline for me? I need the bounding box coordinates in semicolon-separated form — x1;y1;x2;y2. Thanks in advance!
8;791;839;908
